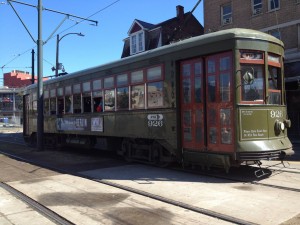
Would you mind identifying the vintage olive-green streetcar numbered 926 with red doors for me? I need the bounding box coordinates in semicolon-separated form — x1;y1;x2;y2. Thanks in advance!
23;28;294;171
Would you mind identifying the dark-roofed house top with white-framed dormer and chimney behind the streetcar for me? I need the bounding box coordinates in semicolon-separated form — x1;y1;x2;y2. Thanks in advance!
121;5;204;58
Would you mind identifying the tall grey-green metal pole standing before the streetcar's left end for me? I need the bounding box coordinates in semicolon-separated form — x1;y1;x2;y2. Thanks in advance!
37;0;44;151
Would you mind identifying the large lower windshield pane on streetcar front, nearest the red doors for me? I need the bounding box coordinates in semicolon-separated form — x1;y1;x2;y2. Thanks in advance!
241;65;264;102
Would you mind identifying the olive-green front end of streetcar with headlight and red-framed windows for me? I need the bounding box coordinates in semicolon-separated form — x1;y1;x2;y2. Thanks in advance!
236;50;294;164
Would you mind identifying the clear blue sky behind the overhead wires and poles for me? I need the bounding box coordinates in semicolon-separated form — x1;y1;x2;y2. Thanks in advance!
0;0;204;86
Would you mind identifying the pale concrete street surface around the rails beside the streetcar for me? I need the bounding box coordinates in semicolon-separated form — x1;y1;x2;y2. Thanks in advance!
0;127;300;225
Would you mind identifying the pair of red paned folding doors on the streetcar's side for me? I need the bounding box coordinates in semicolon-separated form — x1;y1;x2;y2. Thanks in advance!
180;52;234;152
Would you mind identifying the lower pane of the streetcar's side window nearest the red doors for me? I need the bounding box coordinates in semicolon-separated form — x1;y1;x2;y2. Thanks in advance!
147;81;163;108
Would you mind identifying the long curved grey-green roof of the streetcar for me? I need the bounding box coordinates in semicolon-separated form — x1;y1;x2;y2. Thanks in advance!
29;28;283;87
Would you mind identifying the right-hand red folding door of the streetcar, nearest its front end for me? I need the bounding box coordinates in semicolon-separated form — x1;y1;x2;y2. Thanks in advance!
205;52;234;152
